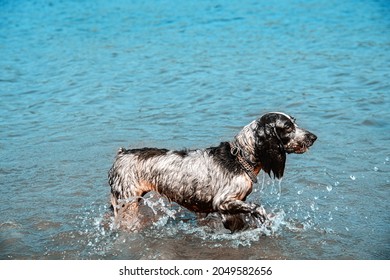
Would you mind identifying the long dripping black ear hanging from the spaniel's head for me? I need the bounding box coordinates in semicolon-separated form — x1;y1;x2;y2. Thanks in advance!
257;124;286;179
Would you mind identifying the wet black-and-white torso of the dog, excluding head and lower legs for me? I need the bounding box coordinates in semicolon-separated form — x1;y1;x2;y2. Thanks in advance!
109;143;250;213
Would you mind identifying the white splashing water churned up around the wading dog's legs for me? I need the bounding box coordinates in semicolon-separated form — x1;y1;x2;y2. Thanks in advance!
74;176;330;258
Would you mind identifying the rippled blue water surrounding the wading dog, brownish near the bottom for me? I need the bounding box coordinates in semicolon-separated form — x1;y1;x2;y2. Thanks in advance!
0;0;390;259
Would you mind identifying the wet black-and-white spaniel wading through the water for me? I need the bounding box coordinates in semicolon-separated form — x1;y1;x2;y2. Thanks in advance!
108;112;317;232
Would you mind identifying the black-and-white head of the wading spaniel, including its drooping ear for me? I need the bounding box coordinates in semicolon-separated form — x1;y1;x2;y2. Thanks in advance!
254;112;317;178
